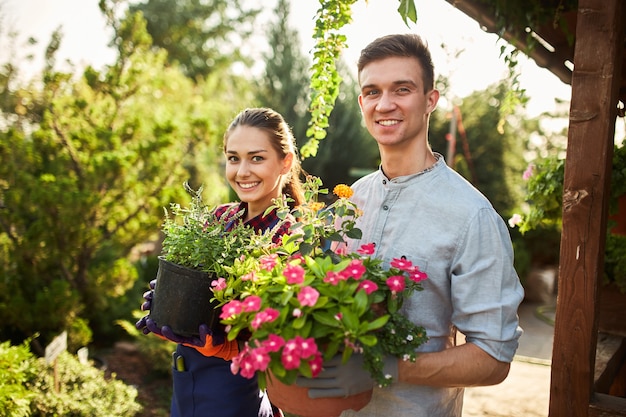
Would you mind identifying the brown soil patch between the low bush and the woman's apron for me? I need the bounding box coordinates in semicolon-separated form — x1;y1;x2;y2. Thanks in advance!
97;342;172;417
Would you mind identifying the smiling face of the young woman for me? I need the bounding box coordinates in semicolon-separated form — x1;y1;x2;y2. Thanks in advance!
225;126;293;220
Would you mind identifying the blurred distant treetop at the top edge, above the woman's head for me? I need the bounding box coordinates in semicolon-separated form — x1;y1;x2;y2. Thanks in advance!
129;0;260;80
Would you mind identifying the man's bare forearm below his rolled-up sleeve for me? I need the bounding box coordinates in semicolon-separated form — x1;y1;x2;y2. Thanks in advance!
398;343;510;387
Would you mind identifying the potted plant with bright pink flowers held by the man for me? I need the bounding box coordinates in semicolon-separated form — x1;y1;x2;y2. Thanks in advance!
213;177;427;416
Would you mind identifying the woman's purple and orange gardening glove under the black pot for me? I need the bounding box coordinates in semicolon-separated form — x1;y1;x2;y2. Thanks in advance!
135;280;239;361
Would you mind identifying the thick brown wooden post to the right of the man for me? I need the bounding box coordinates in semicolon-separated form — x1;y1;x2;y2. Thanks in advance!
549;0;624;417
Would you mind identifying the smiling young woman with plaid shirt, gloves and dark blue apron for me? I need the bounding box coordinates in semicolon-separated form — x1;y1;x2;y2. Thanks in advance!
137;108;304;417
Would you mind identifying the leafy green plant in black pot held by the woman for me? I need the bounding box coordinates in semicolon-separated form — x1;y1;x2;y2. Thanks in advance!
150;183;271;336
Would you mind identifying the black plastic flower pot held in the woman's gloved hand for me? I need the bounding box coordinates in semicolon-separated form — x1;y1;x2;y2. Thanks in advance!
150;257;221;336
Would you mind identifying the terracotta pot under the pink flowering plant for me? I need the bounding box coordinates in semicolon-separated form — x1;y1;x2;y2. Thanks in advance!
267;375;372;417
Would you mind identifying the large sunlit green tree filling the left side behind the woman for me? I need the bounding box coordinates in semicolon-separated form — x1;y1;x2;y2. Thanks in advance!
0;2;254;348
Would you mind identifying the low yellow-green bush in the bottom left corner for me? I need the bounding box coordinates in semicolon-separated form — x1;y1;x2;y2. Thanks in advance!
0;342;141;417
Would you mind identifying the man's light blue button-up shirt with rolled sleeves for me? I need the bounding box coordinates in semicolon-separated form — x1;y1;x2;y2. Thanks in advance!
342;154;524;417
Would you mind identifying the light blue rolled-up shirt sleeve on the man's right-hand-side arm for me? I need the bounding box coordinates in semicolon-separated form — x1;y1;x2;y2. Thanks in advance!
450;209;524;362
